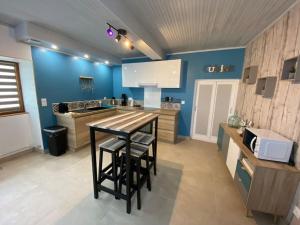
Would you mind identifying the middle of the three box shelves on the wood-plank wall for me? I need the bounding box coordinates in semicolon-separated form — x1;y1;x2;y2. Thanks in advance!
255;77;277;98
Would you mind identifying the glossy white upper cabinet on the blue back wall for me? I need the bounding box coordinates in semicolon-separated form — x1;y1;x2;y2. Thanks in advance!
122;59;182;88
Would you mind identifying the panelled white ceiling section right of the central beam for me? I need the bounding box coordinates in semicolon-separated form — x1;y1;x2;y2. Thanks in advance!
123;0;296;52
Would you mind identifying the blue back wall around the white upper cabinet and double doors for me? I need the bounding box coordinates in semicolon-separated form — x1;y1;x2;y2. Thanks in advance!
113;48;244;136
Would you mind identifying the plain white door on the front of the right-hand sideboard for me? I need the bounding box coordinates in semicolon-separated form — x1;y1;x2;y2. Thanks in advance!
226;138;241;178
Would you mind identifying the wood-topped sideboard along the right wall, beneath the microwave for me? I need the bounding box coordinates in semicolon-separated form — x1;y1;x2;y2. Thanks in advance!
218;124;300;218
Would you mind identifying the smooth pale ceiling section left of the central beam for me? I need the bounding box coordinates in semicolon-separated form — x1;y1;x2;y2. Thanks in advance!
0;0;144;57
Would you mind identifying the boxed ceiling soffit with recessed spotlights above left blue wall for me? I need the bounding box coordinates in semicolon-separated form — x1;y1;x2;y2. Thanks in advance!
15;22;121;64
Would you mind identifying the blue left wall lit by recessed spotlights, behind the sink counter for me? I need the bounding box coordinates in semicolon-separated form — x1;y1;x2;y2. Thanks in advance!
31;47;113;148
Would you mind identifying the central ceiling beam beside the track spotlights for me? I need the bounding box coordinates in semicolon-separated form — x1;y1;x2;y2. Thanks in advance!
100;0;165;60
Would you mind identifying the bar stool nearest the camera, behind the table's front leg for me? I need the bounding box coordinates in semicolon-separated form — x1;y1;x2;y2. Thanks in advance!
118;143;151;209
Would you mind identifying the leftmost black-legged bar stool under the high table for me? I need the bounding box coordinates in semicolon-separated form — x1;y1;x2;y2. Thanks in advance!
98;138;126;199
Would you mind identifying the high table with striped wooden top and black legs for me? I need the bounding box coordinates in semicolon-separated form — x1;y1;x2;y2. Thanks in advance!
87;112;158;213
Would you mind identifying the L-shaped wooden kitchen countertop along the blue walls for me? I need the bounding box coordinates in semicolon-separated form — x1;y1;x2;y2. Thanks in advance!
54;106;180;118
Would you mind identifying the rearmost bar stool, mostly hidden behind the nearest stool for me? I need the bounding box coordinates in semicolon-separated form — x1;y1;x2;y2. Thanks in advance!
131;131;157;175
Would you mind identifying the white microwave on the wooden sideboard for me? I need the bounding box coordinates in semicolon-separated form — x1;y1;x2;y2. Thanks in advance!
243;128;293;163
